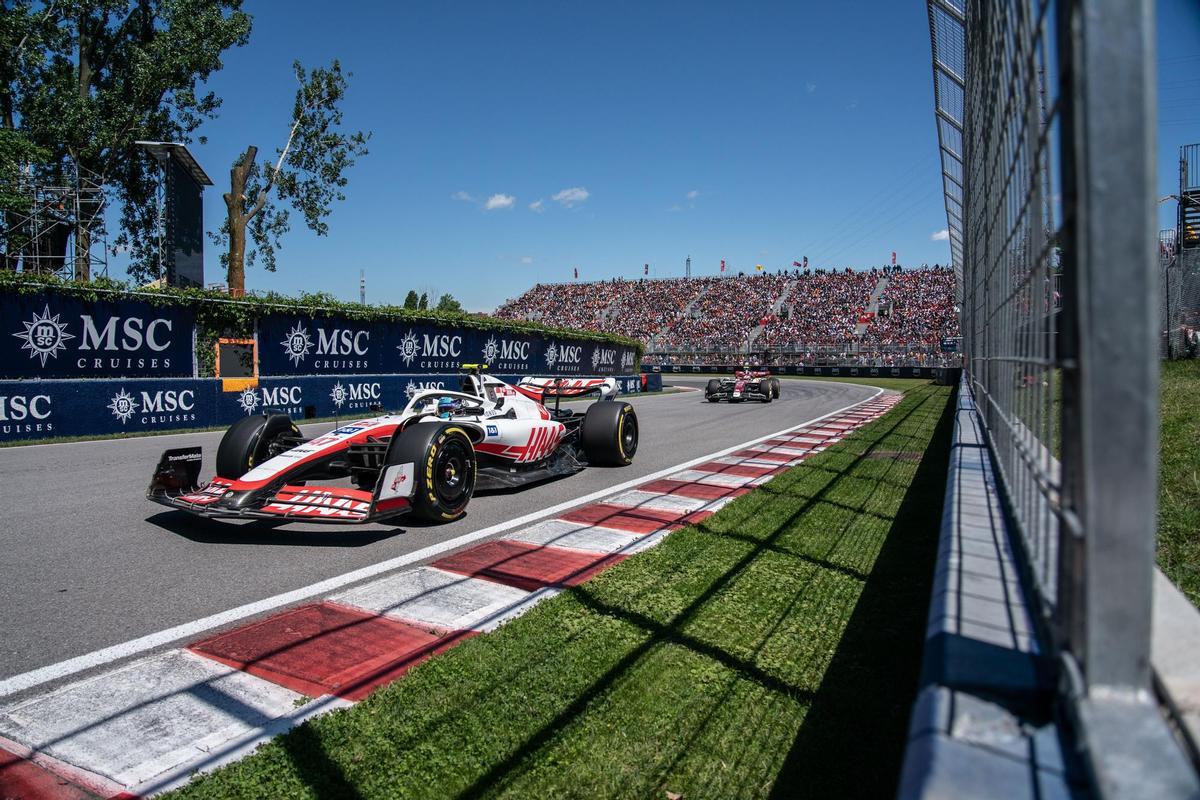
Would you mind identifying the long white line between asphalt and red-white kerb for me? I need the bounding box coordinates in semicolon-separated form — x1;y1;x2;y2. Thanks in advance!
0;389;883;697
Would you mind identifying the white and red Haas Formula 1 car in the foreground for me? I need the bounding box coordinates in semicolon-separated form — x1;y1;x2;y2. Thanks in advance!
146;365;637;523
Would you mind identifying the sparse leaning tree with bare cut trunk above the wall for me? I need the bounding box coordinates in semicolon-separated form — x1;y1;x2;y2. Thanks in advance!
210;59;371;295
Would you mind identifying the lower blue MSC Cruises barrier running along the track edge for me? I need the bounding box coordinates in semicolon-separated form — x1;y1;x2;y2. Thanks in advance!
0;373;662;441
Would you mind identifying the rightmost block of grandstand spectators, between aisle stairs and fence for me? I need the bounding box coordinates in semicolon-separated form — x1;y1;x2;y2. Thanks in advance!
863;267;959;345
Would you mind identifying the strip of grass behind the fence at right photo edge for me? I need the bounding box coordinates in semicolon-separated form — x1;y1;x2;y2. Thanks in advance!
1158;361;1200;607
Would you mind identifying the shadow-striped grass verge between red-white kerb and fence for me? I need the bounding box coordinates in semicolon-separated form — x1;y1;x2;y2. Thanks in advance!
173;385;953;800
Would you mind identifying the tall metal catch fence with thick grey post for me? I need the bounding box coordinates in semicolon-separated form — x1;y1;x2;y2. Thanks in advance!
928;0;1184;796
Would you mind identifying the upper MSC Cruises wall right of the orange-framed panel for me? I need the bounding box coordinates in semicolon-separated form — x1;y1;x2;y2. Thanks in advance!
258;314;637;375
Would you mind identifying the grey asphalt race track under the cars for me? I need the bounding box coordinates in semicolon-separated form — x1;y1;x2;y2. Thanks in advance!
0;378;877;680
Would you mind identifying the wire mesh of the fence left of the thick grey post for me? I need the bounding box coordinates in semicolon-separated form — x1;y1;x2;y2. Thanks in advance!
929;0;1062;612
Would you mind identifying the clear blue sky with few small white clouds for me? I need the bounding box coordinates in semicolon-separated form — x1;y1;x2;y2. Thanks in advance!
114;0;1200;311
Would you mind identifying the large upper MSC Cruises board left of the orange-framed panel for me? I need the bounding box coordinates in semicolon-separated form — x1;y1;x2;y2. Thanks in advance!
0;293;196;378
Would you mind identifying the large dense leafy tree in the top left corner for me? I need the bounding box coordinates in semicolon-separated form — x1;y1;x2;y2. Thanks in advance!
0;0;251;279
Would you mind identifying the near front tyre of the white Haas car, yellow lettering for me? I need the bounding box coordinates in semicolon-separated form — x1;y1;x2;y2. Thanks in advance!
385;422;479;522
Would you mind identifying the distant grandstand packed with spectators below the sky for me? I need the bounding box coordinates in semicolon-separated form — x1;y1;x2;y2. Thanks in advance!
496;265;959;366
